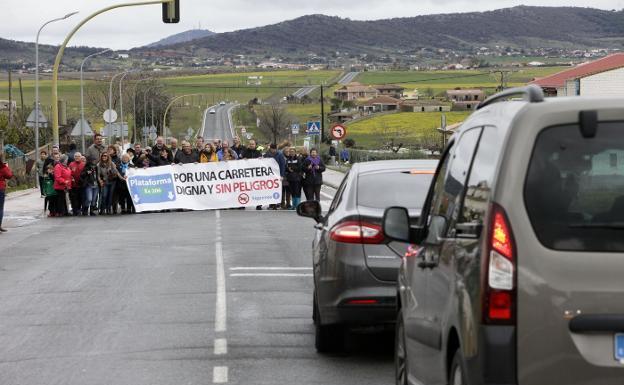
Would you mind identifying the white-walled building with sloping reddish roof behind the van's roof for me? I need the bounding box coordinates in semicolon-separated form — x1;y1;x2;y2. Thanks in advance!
531;53;624;97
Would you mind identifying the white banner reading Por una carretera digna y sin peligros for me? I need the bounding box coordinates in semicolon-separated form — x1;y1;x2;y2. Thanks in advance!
126;158;282;212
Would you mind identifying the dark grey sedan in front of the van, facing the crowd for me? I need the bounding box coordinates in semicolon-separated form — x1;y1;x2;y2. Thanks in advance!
298;160;437;352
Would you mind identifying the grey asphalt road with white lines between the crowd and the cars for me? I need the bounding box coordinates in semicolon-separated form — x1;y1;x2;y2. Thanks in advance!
0;189;393;385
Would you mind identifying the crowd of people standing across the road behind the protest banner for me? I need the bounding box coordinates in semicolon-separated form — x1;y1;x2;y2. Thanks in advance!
31;134;325;216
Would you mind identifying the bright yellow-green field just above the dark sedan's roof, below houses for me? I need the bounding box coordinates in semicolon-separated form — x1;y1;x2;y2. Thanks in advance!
347;112;470;148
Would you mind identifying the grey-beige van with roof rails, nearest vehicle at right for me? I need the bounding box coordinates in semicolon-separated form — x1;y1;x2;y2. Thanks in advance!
384;87;624;385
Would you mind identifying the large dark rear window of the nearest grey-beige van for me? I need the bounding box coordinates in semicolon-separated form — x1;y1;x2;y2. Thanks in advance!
524;122;624;252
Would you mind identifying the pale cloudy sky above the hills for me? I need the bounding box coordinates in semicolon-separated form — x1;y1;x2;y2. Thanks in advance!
0;0;624;49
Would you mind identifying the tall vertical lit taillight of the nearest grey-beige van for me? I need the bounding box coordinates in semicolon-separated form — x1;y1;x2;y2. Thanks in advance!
483;204;517;324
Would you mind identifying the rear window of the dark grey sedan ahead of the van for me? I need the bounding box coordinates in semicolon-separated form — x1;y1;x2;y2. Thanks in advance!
357;170;433;209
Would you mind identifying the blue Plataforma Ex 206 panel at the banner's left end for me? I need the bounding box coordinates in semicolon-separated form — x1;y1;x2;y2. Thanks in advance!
128;174;176;205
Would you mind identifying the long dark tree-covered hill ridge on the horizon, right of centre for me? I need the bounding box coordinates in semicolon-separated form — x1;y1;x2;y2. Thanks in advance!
139;6;624;56
